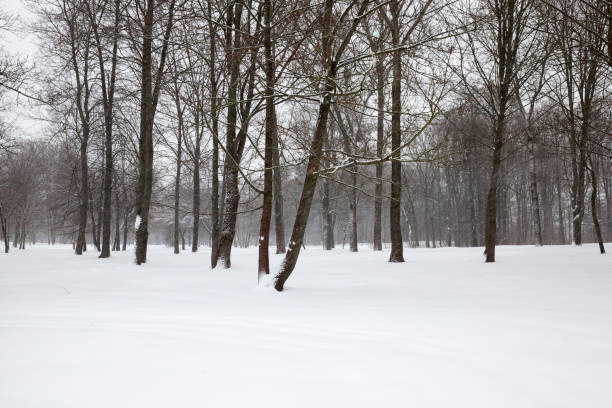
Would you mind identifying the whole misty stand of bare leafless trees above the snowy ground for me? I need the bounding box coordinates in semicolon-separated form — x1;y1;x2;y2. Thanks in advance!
0;0;612;291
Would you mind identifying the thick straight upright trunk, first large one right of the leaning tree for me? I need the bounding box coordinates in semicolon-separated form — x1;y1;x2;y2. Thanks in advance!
389;0;404;262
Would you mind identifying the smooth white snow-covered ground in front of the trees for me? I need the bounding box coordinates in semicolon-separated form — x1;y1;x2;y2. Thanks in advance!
0;245;612;408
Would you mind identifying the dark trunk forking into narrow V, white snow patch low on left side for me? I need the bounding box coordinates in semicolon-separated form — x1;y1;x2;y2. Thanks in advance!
135;0;175;265
